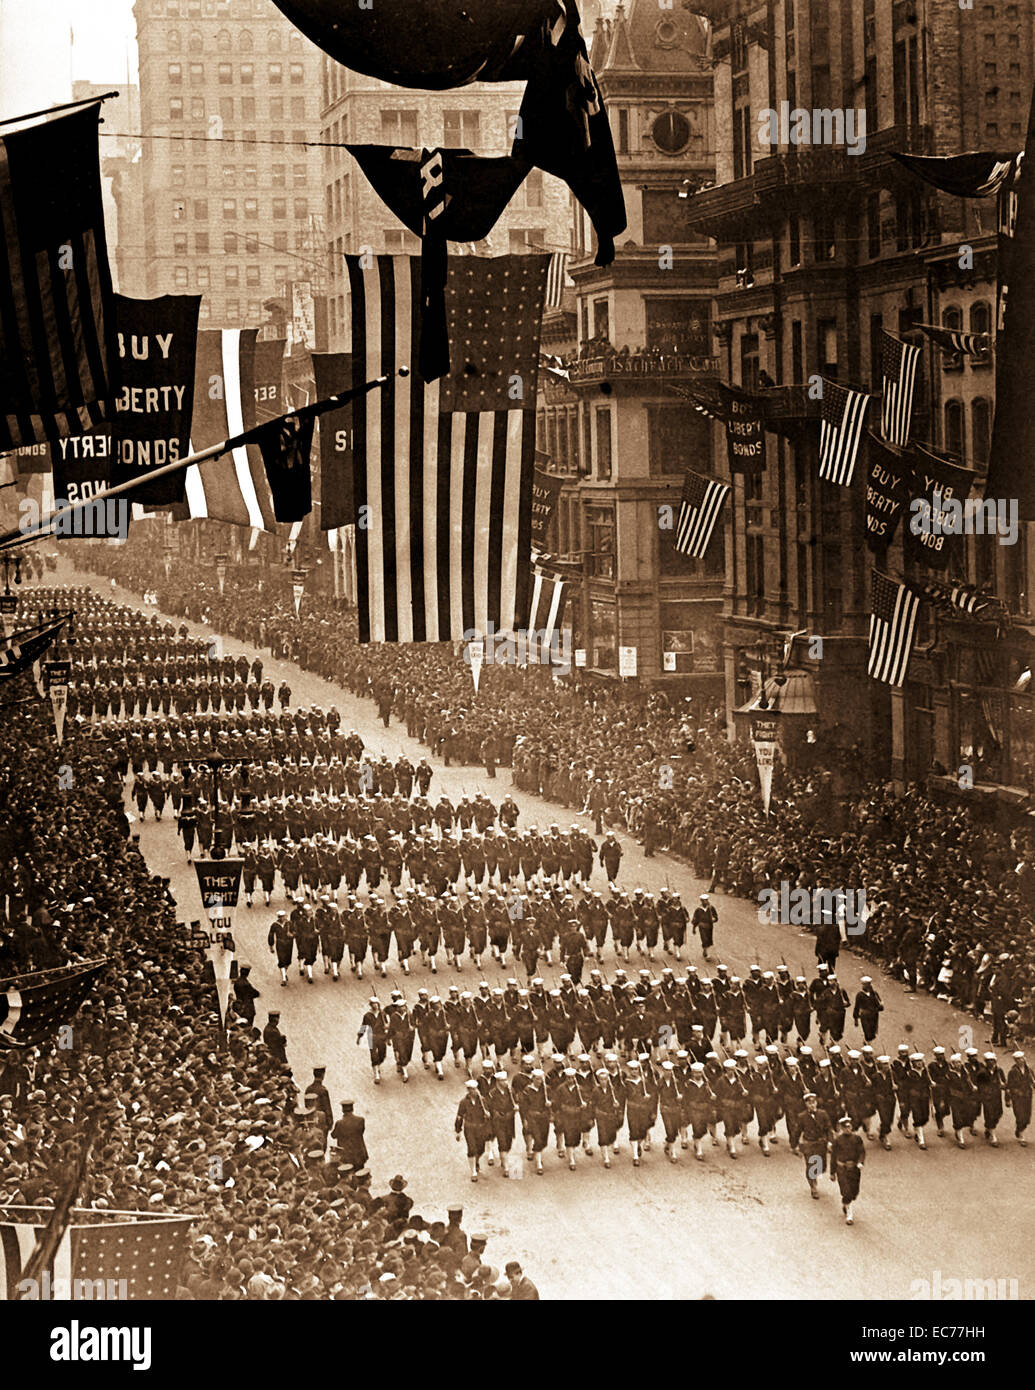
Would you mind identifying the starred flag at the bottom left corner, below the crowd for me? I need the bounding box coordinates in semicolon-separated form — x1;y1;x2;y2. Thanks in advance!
0;1207;193;1302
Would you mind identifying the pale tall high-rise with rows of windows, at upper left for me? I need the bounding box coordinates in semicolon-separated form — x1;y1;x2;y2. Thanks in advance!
126;0;324;334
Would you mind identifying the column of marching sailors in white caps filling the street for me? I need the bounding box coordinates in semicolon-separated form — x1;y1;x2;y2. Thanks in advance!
32;586;1034;1220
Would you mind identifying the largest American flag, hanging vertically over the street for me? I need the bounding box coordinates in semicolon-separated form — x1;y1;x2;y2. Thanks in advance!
346;254;547;642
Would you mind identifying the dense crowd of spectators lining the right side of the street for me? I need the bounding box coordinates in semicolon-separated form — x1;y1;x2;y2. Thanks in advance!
76;546;1035;1037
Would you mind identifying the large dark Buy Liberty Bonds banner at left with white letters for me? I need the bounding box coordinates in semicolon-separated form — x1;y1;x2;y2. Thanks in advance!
111;295;201;506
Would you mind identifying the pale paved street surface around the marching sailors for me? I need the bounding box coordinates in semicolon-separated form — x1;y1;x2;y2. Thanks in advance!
58;567;1035;1300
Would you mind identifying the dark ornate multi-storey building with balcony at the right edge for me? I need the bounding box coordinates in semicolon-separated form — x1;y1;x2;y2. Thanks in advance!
689;0;1035;785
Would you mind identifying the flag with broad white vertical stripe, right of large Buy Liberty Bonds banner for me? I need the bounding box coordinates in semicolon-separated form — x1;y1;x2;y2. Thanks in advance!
186;328;283;531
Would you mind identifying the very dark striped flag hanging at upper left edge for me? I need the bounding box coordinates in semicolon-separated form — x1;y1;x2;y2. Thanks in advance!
0;101;118;450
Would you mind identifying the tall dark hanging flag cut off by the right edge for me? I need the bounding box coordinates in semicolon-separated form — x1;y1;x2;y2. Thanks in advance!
985;86;1035;521
